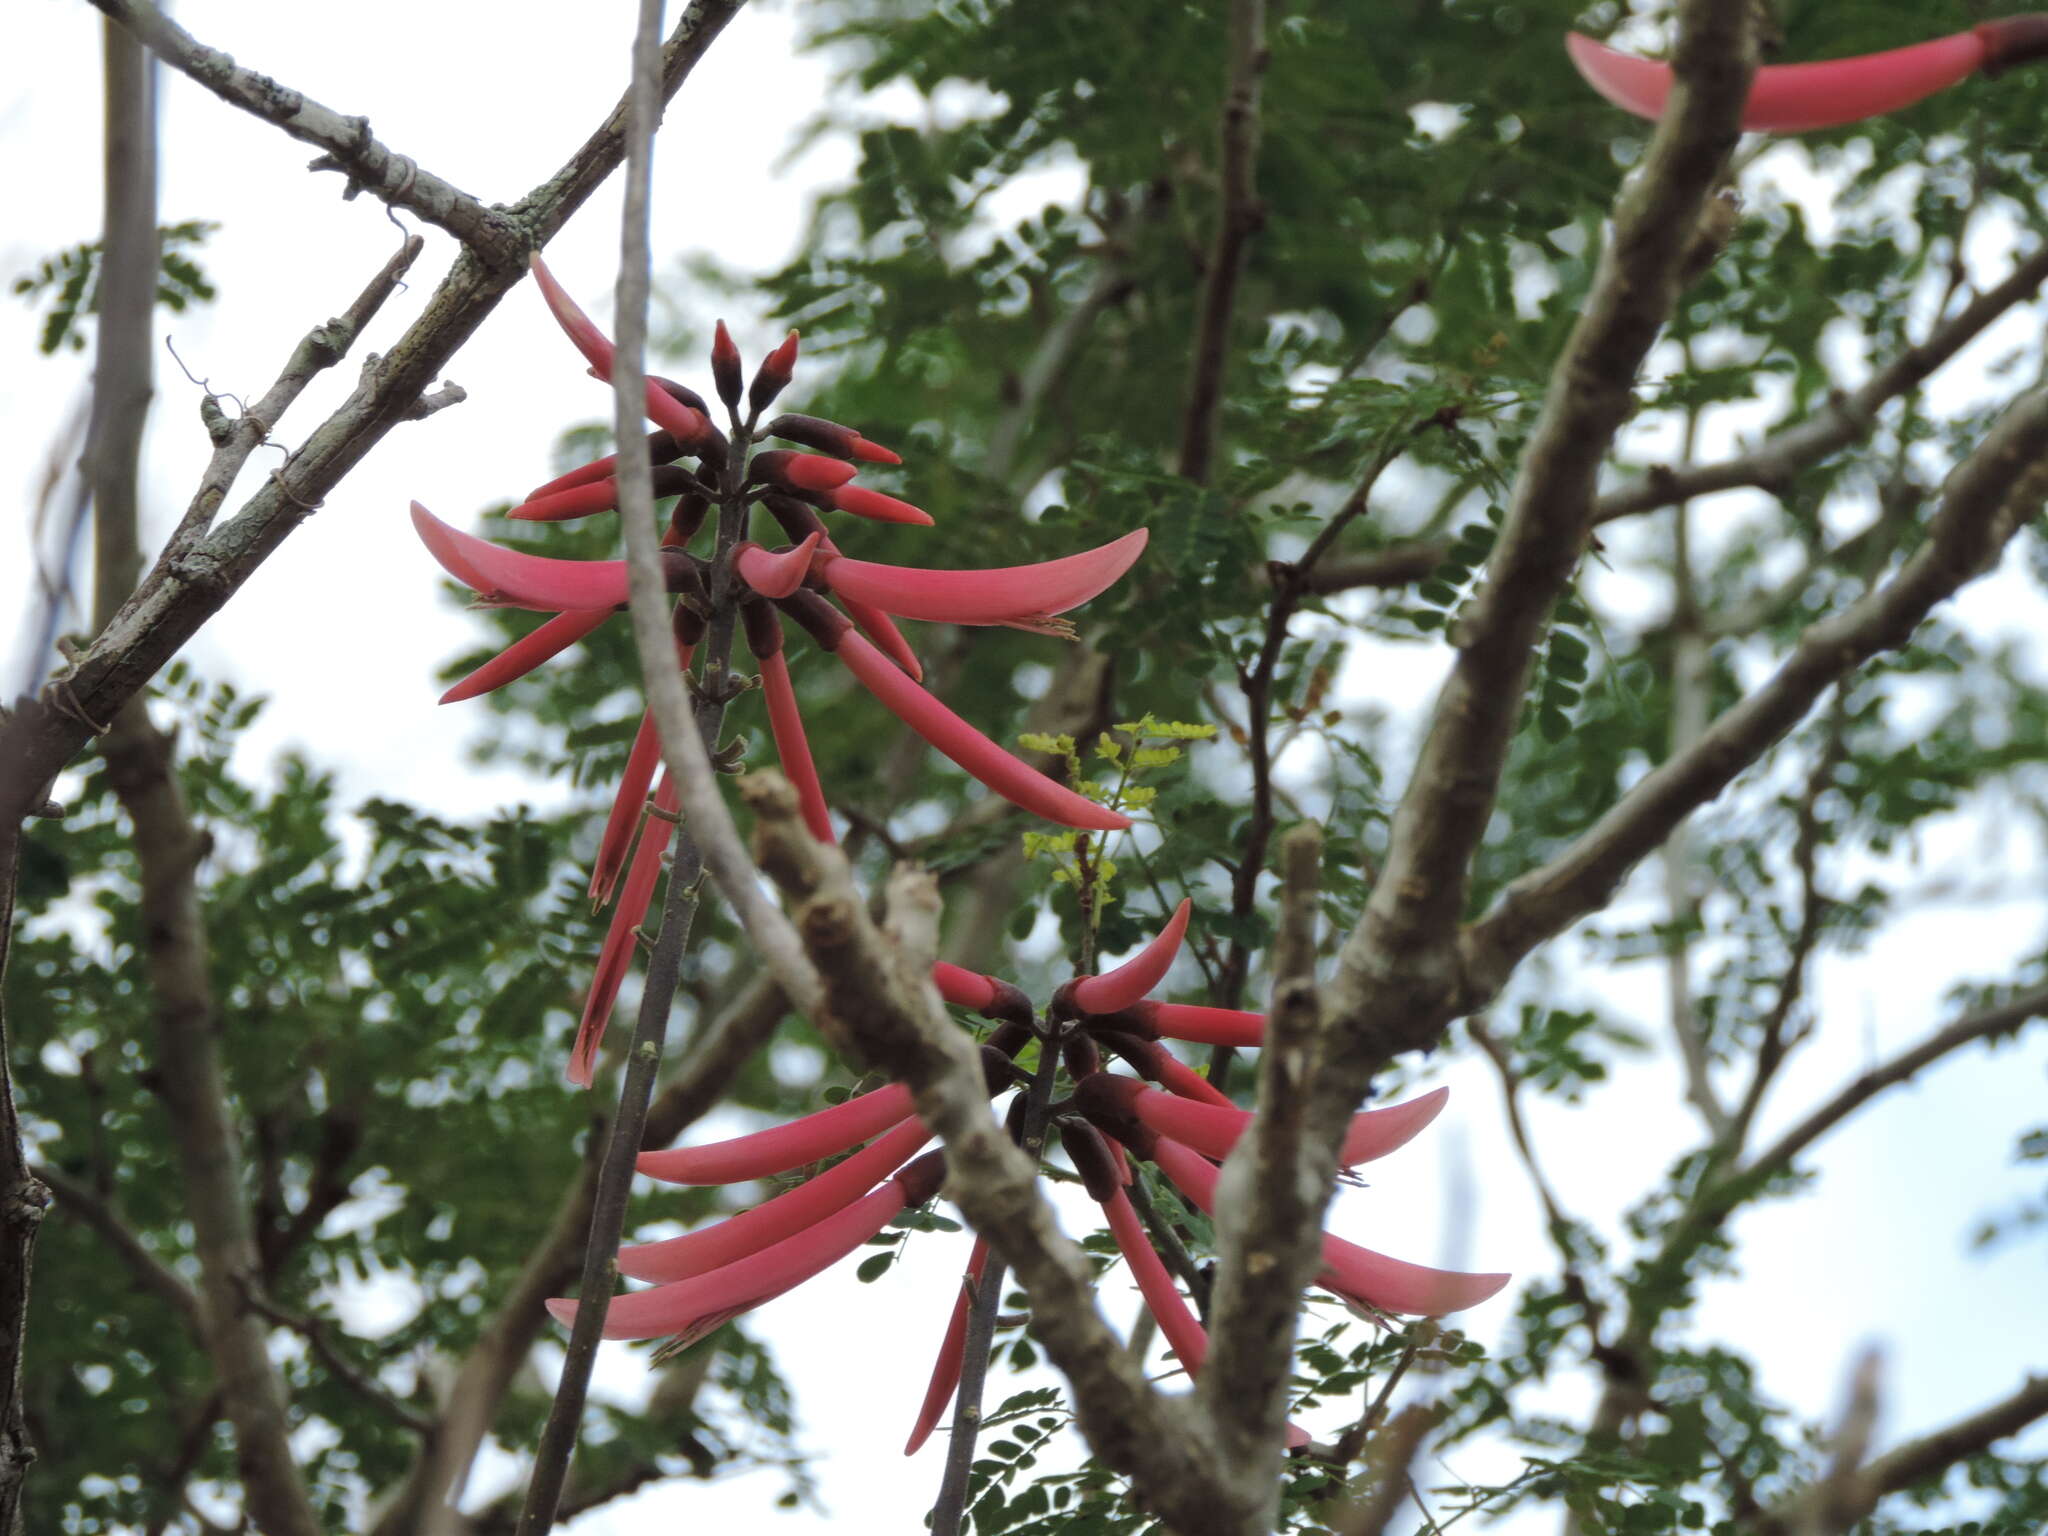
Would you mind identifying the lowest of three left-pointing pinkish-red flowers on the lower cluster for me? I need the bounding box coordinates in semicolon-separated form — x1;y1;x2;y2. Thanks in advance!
547;1153;946;1348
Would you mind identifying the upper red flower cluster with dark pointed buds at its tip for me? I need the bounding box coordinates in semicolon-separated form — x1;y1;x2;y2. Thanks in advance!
412;258;1147;1085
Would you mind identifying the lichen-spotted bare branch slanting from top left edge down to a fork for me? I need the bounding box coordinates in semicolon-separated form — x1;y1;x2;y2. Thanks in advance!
92;0;526;270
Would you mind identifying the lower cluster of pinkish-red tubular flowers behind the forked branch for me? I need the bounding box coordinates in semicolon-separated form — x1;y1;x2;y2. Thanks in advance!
549;901;1507;1454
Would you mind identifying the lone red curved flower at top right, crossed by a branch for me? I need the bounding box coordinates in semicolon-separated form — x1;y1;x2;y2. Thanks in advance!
1565;12;2048;133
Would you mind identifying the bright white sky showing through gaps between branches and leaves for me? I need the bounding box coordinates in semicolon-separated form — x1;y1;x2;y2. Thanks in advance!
0;0;2048;1536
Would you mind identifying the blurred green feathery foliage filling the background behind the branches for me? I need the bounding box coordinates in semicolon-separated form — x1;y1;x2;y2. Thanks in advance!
8;0;2048;1536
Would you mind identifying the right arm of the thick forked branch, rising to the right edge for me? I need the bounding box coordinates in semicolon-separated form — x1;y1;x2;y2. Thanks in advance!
1466;391;2048;1006
